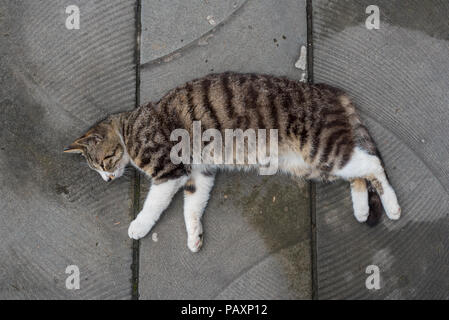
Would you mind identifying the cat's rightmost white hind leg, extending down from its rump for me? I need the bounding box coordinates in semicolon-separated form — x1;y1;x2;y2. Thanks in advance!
334;147;401;220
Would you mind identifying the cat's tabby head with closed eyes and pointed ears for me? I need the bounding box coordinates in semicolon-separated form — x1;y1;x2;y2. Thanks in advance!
64;120;129;181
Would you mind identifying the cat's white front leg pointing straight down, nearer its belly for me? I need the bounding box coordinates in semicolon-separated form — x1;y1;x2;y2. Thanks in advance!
184;169;215;252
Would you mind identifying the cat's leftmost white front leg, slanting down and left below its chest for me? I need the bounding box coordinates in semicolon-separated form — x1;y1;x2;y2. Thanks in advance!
128;176;188;240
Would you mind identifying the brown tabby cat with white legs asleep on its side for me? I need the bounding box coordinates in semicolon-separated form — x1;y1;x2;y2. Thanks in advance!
65;72;401;252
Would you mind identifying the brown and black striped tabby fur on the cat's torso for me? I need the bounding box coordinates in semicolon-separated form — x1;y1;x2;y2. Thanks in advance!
76;72;377;185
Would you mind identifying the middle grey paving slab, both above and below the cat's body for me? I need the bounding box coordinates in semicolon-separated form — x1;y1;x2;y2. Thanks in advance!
139;0;311;299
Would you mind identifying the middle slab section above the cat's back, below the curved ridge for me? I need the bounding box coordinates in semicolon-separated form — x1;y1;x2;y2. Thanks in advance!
141;0;307;102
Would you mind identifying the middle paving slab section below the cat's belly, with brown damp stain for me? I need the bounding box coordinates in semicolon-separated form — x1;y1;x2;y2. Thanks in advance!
139;173;311;299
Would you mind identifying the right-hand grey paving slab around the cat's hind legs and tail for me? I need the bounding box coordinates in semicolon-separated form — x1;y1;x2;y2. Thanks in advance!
313;0;449;299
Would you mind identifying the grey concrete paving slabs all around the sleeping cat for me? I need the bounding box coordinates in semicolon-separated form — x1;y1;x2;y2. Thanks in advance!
0;0;449;299
